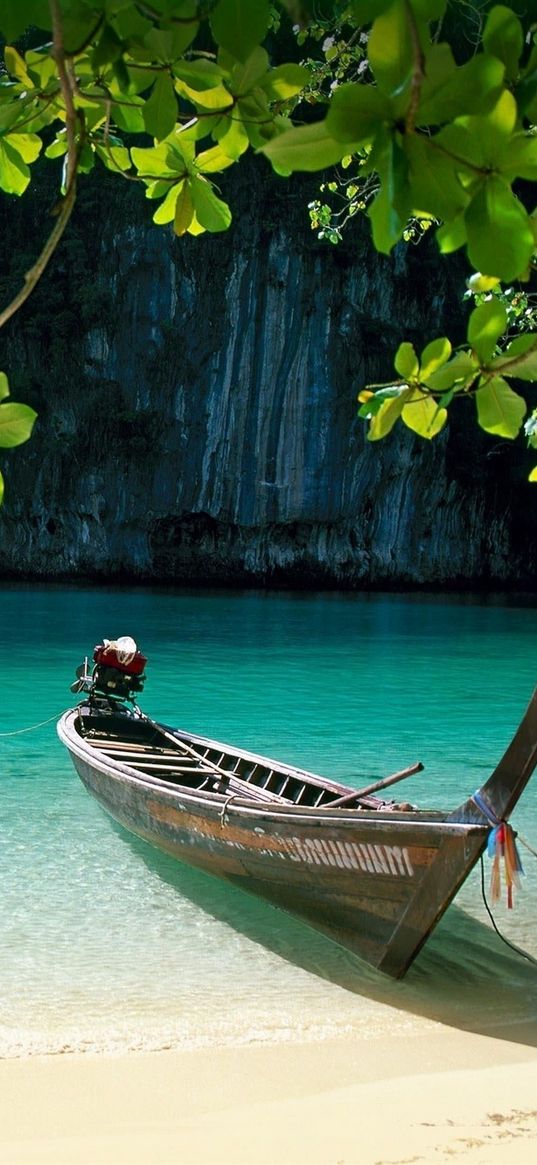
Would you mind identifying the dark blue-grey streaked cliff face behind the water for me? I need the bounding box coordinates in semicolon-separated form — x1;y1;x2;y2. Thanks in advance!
0;164;537;587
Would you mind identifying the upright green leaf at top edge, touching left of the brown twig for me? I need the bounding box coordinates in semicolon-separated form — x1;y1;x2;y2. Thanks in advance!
368;0;414;97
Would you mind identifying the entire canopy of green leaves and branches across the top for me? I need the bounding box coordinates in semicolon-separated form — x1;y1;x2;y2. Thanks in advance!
0;0;537;493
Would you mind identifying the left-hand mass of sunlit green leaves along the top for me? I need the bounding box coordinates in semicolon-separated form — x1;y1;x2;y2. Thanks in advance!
0;0;308;235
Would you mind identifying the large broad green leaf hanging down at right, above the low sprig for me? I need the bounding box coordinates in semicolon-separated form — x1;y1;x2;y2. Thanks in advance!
465;175;534;282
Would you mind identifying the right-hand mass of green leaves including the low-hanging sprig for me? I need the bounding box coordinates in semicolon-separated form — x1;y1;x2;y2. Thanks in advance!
263;0;537;480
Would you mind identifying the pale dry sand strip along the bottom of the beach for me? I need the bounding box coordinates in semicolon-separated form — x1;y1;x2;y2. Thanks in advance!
0;1023;537;1165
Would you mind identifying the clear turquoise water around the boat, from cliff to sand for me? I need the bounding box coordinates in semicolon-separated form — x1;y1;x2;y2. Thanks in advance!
0;586;537;1057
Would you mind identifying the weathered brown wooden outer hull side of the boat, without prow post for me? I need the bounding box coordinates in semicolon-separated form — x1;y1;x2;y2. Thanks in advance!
58;714;488;977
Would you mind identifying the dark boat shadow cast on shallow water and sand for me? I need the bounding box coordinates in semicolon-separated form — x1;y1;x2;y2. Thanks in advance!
113;824;537;1047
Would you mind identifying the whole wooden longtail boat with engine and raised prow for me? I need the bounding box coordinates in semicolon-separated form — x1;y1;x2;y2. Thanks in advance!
58;640;537;977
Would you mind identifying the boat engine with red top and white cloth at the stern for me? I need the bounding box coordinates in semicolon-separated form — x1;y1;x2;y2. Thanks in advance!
71;635;147;700
